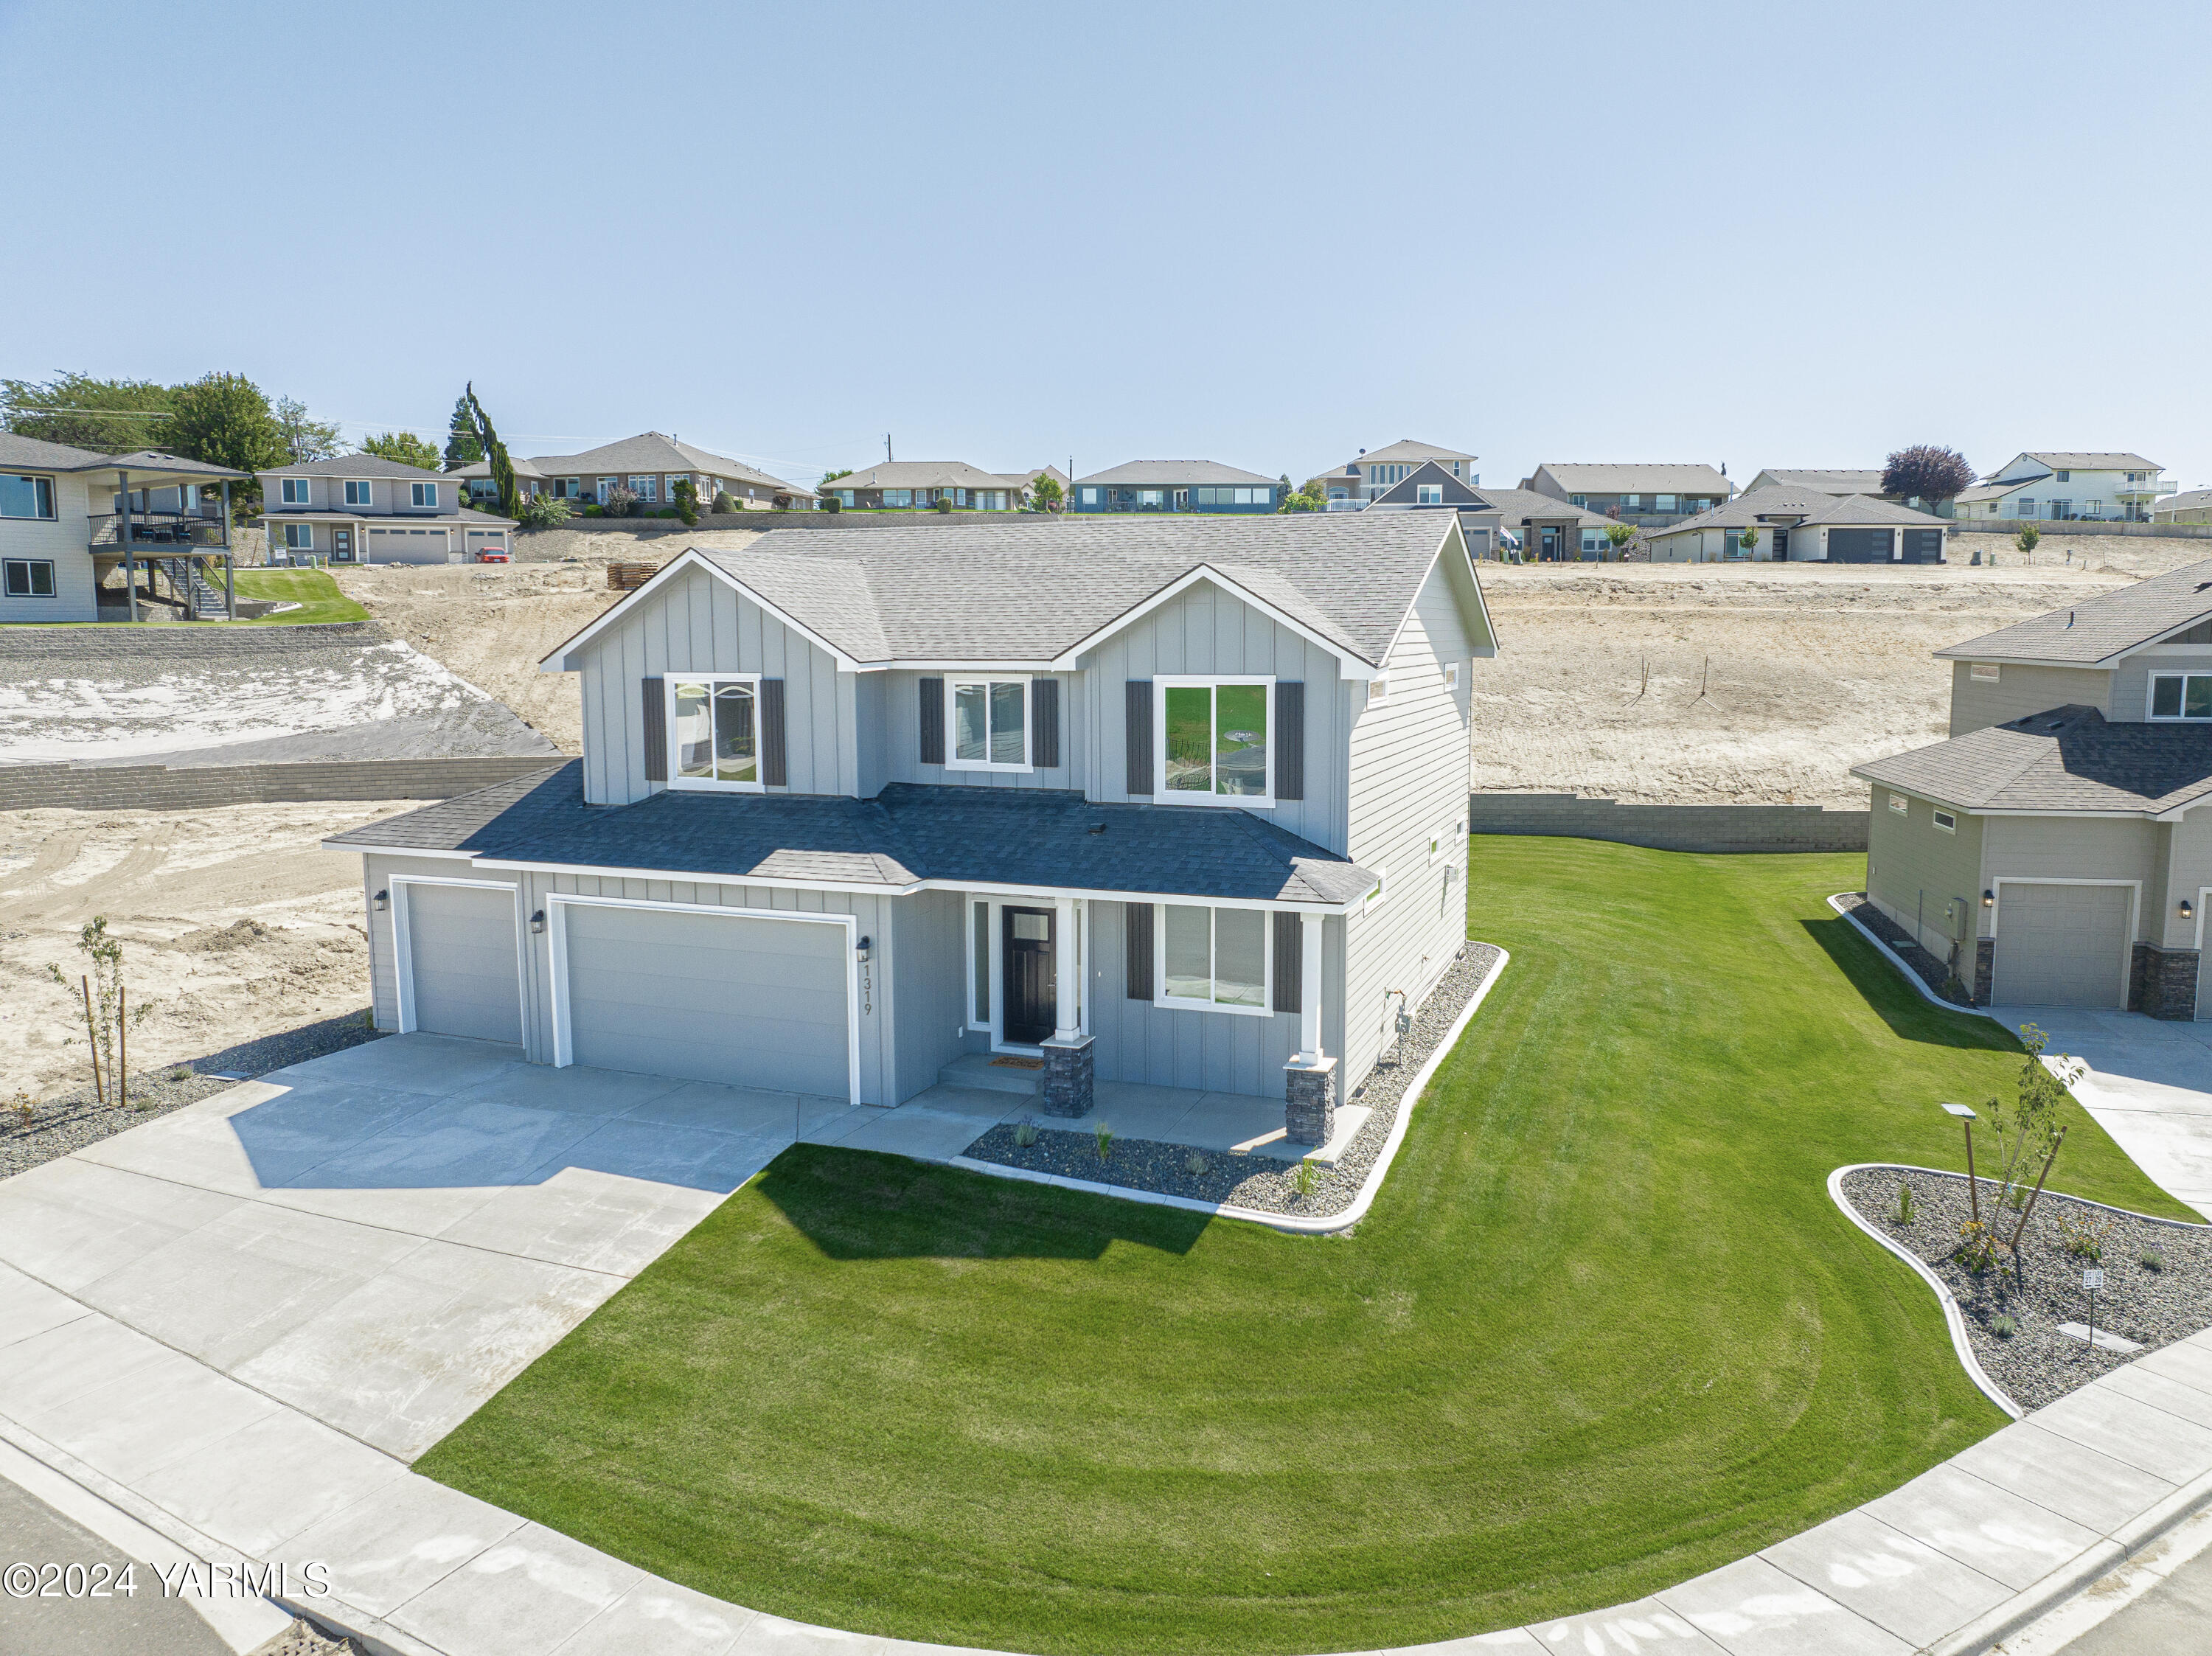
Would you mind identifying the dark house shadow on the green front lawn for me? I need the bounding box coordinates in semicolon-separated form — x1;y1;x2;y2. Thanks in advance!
752;1145;1212;1260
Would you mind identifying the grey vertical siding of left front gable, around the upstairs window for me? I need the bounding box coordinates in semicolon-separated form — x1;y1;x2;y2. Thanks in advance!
580;571;860;805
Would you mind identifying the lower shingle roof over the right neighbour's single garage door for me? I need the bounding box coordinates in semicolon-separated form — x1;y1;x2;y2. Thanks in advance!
1851;708;2212;814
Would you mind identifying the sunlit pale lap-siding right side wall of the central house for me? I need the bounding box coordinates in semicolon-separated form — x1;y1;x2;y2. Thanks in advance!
1340;560;1486;1088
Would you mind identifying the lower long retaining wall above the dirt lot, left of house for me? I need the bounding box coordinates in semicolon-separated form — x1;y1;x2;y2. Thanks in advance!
0;754;562;812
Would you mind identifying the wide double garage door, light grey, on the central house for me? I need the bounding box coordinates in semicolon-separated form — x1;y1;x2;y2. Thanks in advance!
562;904;852;1099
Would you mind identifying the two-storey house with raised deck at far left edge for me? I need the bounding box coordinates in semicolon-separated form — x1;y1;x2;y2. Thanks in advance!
0;431;248;622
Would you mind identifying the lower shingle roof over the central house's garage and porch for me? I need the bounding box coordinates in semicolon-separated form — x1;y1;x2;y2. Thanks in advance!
325;761;1374;904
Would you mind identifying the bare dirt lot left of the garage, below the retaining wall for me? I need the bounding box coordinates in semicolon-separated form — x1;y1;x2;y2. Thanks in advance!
0;801;407;1101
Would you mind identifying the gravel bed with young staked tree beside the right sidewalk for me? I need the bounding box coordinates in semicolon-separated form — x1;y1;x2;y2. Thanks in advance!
1843;1167;2212;1408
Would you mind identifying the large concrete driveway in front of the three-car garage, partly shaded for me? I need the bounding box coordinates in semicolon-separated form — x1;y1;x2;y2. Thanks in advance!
0;1034;863;1461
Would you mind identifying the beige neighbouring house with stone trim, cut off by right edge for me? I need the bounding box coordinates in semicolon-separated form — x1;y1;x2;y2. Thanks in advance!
1851;562;2212;1019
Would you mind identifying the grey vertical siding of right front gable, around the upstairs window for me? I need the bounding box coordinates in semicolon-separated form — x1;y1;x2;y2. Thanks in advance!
1062;584;1352;851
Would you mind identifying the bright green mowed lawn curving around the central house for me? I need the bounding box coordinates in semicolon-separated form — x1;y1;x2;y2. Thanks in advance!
418;838;2188;1652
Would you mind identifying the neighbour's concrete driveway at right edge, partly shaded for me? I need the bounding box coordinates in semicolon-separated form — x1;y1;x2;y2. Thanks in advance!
1989;1006;2212;1218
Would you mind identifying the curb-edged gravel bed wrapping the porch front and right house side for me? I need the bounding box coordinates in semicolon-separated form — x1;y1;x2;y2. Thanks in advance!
964;942;1500;1218
